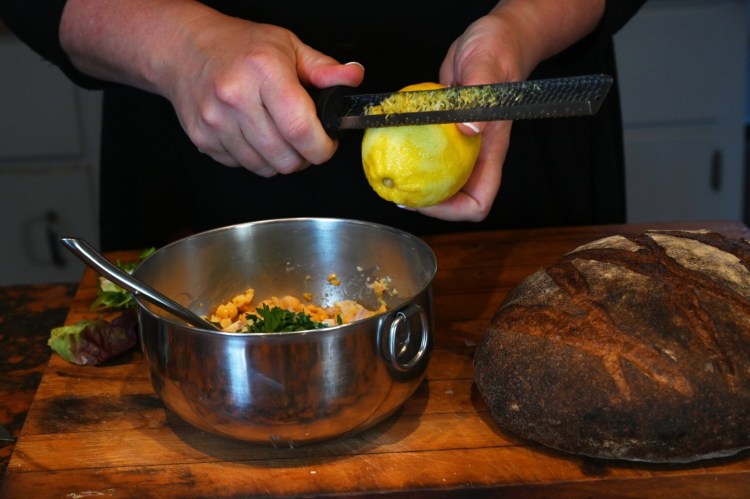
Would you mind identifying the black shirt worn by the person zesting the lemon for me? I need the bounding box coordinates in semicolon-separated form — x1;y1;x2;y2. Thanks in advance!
0;0;645;250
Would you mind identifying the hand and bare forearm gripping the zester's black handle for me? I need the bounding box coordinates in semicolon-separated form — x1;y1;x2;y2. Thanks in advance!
60;0;364;176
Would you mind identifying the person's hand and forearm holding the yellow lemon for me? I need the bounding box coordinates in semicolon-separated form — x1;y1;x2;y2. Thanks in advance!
419;0;604;221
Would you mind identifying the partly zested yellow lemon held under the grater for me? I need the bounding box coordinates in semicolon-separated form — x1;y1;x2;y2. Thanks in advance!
362;83;481;208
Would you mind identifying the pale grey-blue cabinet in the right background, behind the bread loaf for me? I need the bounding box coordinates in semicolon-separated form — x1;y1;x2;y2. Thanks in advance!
615;0;748;222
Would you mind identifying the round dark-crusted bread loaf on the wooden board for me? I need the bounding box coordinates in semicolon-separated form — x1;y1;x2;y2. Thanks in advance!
474;231;750;462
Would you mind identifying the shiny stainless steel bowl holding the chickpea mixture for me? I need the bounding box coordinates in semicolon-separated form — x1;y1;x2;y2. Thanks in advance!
129;218;437;446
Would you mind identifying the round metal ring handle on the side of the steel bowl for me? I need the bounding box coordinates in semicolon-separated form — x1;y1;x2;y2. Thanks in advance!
384;304;430;372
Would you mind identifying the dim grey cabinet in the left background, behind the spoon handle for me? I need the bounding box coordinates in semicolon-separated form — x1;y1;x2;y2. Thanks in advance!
0;33;101;285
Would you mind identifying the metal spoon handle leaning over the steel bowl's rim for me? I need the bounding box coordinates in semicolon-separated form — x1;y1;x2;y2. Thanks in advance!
60;237;219;331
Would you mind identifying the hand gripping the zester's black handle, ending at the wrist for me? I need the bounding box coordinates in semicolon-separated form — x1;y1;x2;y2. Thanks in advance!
166;15;364;176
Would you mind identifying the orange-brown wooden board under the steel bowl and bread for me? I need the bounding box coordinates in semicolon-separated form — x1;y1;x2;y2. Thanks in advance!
0;222;750;498
